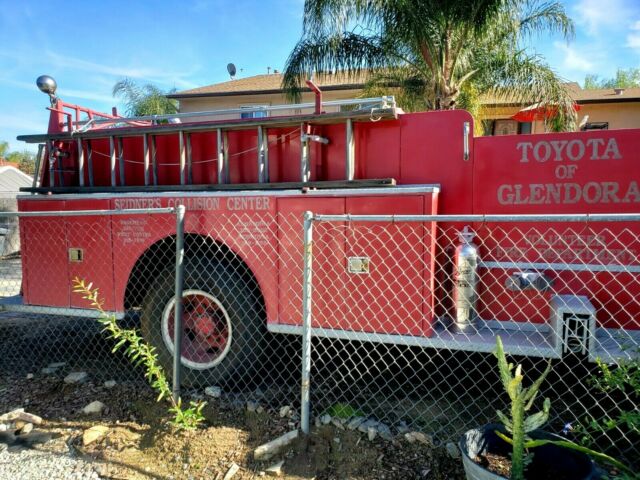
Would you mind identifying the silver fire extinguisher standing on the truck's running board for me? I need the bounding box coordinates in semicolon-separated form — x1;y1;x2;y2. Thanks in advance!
453;226;480;333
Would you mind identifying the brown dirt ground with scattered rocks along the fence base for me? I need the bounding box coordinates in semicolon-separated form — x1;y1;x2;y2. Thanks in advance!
0;374;464;480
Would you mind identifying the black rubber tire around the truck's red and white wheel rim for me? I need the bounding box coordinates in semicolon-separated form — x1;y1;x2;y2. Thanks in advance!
141;259;266;387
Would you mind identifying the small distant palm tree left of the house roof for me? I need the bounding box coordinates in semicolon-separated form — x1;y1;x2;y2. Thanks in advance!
113;78;178;117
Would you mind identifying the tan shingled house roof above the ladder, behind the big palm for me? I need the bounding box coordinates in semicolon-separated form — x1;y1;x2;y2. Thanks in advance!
167;73;366;99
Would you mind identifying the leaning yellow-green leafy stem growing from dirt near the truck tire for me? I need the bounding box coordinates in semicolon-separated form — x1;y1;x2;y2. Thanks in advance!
73;277;206;430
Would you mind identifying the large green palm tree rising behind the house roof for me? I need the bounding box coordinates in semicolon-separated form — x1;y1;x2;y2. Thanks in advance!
283;0;575;127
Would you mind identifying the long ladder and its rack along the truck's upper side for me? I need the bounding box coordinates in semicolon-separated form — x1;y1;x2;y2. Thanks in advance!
18;97;401;192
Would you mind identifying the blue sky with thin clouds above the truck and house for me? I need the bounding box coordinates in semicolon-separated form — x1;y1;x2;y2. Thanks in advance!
0;0;640;149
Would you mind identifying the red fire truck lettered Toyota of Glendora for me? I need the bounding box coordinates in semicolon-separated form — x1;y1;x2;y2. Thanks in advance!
10;77;640;379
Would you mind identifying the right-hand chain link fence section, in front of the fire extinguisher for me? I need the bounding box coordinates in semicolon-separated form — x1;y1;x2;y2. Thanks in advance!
302;213;640;460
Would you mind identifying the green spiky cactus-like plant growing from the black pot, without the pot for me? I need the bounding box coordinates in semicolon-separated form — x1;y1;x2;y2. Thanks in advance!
495;336;637;480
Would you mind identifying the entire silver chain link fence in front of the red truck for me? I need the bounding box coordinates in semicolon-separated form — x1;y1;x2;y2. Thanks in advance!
0;205;640;468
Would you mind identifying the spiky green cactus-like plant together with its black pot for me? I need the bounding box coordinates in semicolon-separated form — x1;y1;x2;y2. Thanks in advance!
459;337;626;480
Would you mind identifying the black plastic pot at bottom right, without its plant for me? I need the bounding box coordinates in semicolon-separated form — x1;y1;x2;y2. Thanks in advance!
459;424;598;480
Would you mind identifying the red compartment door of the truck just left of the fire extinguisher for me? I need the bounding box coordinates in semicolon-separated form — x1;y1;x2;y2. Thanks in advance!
342;196;429;335
